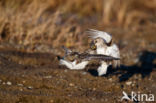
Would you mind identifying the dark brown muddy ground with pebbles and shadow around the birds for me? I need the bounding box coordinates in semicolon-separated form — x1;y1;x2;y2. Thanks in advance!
0;26;156;103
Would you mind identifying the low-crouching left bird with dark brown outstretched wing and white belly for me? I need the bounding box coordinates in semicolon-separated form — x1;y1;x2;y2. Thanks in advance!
59;46;120;70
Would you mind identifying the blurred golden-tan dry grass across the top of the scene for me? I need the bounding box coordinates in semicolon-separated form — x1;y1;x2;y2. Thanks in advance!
0;0;156;51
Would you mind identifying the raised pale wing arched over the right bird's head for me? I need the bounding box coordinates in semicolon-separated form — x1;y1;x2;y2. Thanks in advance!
86;29;112;43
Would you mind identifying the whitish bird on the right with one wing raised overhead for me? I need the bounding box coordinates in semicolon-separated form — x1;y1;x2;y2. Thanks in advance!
87;29;120;76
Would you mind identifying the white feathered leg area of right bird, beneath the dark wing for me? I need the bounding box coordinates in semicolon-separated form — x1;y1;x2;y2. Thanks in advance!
97;61;108;76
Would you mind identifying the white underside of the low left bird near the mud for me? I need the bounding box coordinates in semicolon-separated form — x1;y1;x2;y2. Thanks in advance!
60;59;89;70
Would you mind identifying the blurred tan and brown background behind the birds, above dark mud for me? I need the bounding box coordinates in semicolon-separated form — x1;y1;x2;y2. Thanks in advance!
0;0;156;52
